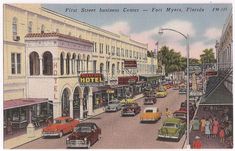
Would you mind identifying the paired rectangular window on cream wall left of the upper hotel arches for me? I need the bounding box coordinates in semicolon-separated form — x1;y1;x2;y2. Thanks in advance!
11;53;21;74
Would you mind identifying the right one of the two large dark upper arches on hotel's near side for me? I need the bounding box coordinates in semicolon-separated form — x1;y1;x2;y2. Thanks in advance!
43;51;53;75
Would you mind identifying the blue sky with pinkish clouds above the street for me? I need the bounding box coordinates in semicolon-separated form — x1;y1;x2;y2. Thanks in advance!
43;4;232;58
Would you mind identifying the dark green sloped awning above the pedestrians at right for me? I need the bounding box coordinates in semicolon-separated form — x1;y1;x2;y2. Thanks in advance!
200;84;233;105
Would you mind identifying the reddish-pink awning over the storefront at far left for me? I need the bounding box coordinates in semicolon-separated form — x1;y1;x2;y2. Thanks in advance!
4;98;48;110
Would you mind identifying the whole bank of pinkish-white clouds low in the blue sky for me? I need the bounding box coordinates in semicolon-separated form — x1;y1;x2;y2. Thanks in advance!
102;20;216;59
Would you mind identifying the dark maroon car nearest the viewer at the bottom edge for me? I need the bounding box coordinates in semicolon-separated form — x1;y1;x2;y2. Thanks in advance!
66;122;101;148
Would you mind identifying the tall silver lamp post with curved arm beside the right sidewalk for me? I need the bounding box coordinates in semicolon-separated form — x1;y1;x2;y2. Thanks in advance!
158;28;189;146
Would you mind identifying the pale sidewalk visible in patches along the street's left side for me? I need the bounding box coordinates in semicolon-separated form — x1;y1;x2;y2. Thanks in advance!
3;94;143;149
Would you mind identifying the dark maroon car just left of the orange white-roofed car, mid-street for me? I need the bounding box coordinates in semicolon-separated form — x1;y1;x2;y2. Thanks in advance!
121;103;141;116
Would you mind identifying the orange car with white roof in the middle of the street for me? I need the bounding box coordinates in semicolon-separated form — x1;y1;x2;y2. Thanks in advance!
140;107;162;122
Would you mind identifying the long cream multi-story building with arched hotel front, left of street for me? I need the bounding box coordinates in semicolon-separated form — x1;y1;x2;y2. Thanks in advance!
4;4;157;127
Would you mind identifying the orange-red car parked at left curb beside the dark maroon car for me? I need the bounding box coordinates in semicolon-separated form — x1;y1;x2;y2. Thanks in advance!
42;116;79;138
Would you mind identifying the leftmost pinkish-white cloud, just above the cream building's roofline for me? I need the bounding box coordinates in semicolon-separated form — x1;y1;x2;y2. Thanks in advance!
101;21;131;35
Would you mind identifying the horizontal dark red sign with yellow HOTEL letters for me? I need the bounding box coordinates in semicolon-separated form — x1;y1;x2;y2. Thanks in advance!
79;73;104;86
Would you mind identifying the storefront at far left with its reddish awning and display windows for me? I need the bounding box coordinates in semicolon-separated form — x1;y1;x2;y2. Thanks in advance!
4;99;53;134
